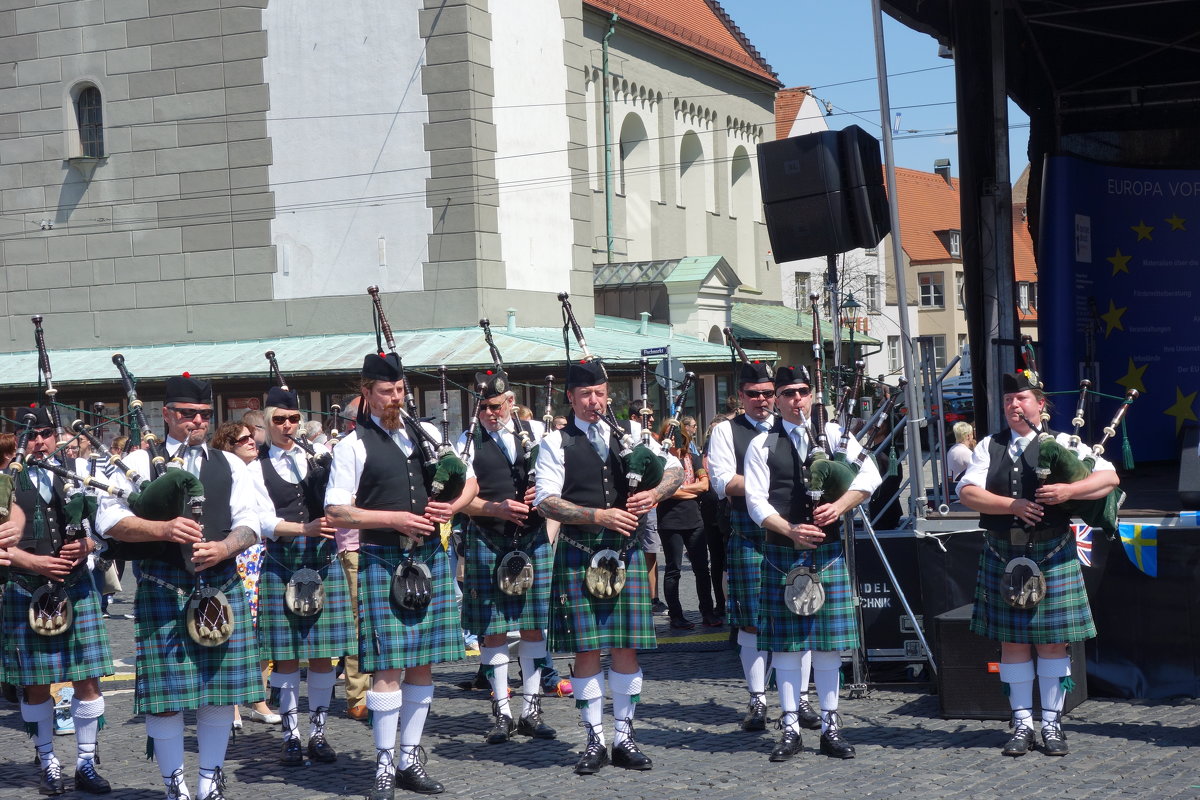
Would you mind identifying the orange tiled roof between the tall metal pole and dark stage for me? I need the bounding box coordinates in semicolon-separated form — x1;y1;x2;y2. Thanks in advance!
896;167;962;264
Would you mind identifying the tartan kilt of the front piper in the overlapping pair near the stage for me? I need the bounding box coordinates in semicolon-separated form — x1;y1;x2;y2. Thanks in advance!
757;540;858;652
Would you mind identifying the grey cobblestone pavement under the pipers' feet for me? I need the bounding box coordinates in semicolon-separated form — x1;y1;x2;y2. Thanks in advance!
0;592;1200;800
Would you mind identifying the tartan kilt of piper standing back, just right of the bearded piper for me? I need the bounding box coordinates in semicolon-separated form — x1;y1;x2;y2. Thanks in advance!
462;522;554;636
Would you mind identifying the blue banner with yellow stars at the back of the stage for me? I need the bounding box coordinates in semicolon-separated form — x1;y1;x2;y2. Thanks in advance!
1038;157;1200;461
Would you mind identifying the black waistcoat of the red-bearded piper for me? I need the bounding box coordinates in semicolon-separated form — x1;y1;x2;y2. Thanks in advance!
354;420;430;545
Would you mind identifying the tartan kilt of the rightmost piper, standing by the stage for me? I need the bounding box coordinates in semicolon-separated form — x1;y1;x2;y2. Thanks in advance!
971;531;1096;644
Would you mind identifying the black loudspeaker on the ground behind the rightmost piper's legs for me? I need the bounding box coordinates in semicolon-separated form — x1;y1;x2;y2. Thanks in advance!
930;606;1087;720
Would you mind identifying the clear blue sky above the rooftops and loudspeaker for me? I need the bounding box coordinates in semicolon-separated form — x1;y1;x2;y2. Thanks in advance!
721;0;1028;180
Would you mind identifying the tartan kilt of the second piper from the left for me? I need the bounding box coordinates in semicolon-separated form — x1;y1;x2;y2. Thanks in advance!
133;559;266;714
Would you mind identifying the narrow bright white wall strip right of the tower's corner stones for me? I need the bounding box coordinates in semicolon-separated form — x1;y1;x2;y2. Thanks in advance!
488;0;576;291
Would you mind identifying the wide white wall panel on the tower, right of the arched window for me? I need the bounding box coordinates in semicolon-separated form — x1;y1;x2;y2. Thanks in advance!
263;0;431;297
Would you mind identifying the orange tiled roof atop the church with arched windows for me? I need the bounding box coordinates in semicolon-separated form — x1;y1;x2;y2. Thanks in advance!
583;0;780;86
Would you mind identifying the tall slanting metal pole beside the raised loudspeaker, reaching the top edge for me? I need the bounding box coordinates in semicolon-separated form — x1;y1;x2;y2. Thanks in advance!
871;0;925;518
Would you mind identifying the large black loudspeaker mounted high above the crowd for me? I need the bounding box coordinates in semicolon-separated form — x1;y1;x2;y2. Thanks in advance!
758;125;892;264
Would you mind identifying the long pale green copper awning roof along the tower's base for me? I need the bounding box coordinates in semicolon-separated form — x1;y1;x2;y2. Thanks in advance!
0;317;775;389
